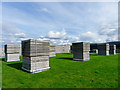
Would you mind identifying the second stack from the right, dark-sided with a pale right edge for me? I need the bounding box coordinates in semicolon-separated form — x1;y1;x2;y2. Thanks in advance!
98;43;109;56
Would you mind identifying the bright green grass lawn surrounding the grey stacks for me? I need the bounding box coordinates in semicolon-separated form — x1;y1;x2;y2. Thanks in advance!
0;53;118;88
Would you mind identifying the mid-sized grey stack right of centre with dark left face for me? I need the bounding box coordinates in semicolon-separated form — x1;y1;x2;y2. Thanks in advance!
72;42;90;61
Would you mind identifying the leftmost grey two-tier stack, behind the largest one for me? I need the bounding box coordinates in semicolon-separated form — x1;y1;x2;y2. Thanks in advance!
5;44;20;62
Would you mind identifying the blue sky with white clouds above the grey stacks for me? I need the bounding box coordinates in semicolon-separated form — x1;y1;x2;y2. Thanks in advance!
1;2;118;44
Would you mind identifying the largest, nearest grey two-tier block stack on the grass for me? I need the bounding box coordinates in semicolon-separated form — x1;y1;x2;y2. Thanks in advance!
22;39;50;73
